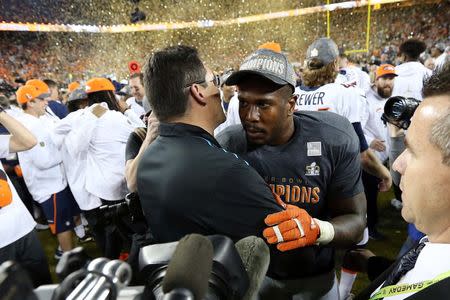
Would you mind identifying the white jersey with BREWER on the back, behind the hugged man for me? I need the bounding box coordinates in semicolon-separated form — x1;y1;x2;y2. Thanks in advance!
294;83;364;123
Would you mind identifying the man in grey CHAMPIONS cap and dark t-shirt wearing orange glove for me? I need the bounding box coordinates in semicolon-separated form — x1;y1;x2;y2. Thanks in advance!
217;45;365;299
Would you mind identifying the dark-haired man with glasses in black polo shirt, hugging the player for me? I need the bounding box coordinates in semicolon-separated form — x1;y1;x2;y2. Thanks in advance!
137;46;282;243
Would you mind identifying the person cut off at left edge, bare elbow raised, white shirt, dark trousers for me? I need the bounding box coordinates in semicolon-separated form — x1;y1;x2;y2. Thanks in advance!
0;108;51;287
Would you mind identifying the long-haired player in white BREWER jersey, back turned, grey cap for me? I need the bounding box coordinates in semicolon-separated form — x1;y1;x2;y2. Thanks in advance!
295;38;392;296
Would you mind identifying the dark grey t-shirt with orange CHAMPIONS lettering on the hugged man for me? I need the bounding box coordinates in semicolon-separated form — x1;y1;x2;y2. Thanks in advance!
217;112;363;279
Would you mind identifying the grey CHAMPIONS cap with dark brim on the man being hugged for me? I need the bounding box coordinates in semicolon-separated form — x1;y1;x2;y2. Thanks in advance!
225;49;296;88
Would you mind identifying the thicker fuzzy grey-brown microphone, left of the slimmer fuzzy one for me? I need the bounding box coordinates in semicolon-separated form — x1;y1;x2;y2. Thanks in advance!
162;234;214;300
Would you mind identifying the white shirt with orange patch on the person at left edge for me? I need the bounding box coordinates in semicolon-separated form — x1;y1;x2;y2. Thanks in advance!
0;135;36;248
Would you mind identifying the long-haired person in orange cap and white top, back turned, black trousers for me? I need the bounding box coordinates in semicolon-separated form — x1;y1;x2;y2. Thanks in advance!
66;78;144;258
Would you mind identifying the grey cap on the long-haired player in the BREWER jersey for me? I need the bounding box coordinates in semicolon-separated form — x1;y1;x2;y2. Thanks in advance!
306;38;339;69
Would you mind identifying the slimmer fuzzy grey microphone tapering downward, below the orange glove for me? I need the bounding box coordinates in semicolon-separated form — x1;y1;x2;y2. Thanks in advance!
235;236;270;300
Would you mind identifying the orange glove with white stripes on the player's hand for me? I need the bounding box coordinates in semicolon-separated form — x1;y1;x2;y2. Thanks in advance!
263;204;320;252
